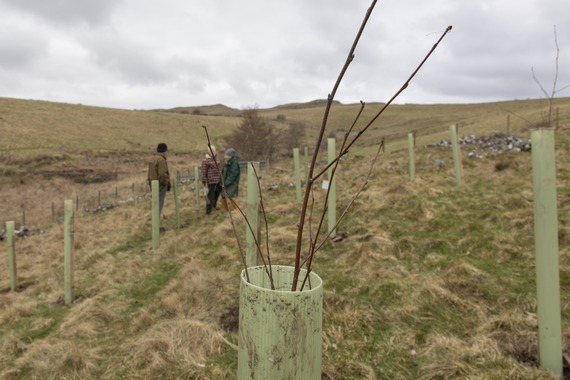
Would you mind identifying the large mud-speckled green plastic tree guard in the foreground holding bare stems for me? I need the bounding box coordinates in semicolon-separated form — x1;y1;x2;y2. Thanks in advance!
237;265;323;380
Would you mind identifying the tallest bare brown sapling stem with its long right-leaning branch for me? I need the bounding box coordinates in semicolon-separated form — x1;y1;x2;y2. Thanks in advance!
291;6;452;291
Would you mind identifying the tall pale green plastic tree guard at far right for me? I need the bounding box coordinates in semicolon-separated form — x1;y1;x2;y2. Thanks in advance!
531;129;562;378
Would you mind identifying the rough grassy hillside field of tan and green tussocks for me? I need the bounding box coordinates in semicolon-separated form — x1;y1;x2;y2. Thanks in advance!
0;98;570;380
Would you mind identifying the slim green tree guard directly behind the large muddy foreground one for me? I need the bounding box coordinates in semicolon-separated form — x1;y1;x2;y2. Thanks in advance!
245;162;259;268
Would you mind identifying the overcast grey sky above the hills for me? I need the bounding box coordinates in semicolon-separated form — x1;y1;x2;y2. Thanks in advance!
0;0;570;109
